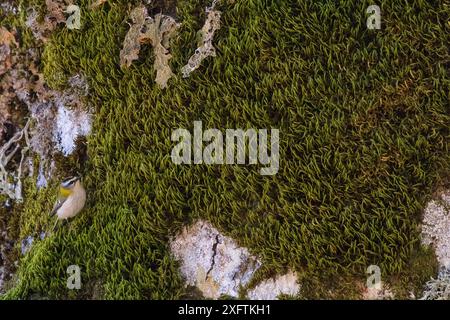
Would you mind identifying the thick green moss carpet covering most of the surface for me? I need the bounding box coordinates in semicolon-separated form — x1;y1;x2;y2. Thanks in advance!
1;0;450;299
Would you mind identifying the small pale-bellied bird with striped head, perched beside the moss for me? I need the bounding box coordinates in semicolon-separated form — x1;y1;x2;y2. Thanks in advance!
50;177;86;230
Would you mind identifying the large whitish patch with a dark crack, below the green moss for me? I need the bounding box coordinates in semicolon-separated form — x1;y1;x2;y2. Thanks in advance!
170;220;261;299
